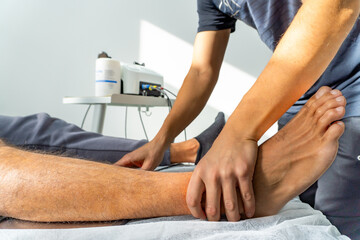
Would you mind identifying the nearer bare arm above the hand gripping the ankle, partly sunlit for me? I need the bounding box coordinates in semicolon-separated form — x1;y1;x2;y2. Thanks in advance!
227;0;360;140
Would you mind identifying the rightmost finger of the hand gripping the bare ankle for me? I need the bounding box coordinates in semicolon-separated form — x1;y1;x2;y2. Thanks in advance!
239;177;255;218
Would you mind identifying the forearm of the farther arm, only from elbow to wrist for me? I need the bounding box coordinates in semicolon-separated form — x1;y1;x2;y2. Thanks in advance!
155;67;217;144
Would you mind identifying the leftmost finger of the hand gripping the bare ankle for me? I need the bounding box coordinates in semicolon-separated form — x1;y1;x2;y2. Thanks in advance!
186;174;206;220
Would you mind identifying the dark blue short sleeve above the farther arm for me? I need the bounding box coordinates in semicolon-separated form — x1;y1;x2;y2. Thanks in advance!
197;0;236;32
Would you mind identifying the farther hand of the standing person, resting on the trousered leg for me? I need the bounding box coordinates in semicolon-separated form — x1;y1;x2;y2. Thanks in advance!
115;140;167;170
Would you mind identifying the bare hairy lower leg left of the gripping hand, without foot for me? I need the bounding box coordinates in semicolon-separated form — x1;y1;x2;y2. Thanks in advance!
0;140;191;222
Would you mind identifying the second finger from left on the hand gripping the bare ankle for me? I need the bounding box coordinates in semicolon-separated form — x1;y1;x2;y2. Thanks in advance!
205;180;221;221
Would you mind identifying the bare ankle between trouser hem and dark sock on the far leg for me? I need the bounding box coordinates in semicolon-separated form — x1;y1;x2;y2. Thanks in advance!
170;138;200;163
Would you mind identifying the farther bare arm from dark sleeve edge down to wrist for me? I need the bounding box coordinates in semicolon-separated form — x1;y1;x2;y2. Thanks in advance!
150;29;230;144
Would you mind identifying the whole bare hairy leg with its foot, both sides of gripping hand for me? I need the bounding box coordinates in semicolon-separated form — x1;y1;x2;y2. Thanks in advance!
0;89;345;221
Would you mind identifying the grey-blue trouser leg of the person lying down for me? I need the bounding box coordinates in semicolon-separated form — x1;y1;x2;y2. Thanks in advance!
0;113;171;165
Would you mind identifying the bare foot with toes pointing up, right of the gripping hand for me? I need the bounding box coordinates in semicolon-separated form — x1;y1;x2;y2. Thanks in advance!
254;87;346;216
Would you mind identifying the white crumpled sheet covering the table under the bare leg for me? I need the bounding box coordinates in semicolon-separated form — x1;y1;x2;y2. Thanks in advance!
0;198;349;240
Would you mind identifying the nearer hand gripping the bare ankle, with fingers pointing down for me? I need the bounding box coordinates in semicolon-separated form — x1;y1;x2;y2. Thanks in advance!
186;129;258;221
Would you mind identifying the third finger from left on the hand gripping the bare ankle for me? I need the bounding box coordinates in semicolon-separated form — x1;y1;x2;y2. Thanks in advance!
222;178;242;222
